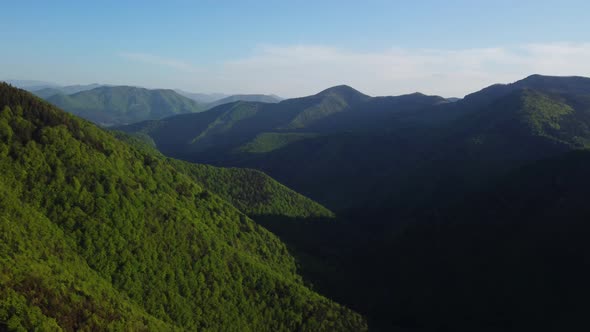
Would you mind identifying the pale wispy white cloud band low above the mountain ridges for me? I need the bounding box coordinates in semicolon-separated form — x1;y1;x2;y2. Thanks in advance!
118;42;590;97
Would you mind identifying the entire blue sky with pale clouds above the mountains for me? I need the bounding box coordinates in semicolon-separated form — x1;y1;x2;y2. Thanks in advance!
0;0;590;97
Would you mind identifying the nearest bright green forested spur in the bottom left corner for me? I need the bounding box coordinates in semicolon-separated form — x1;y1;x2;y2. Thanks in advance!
0;181;175;331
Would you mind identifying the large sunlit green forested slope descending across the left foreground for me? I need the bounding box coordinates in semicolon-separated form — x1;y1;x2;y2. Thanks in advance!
0;84;365;331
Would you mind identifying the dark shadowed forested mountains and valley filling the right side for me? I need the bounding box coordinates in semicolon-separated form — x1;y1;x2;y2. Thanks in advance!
119;75;590;331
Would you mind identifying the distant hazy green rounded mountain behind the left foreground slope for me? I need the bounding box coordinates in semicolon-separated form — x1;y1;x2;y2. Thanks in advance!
47;86;203;126
